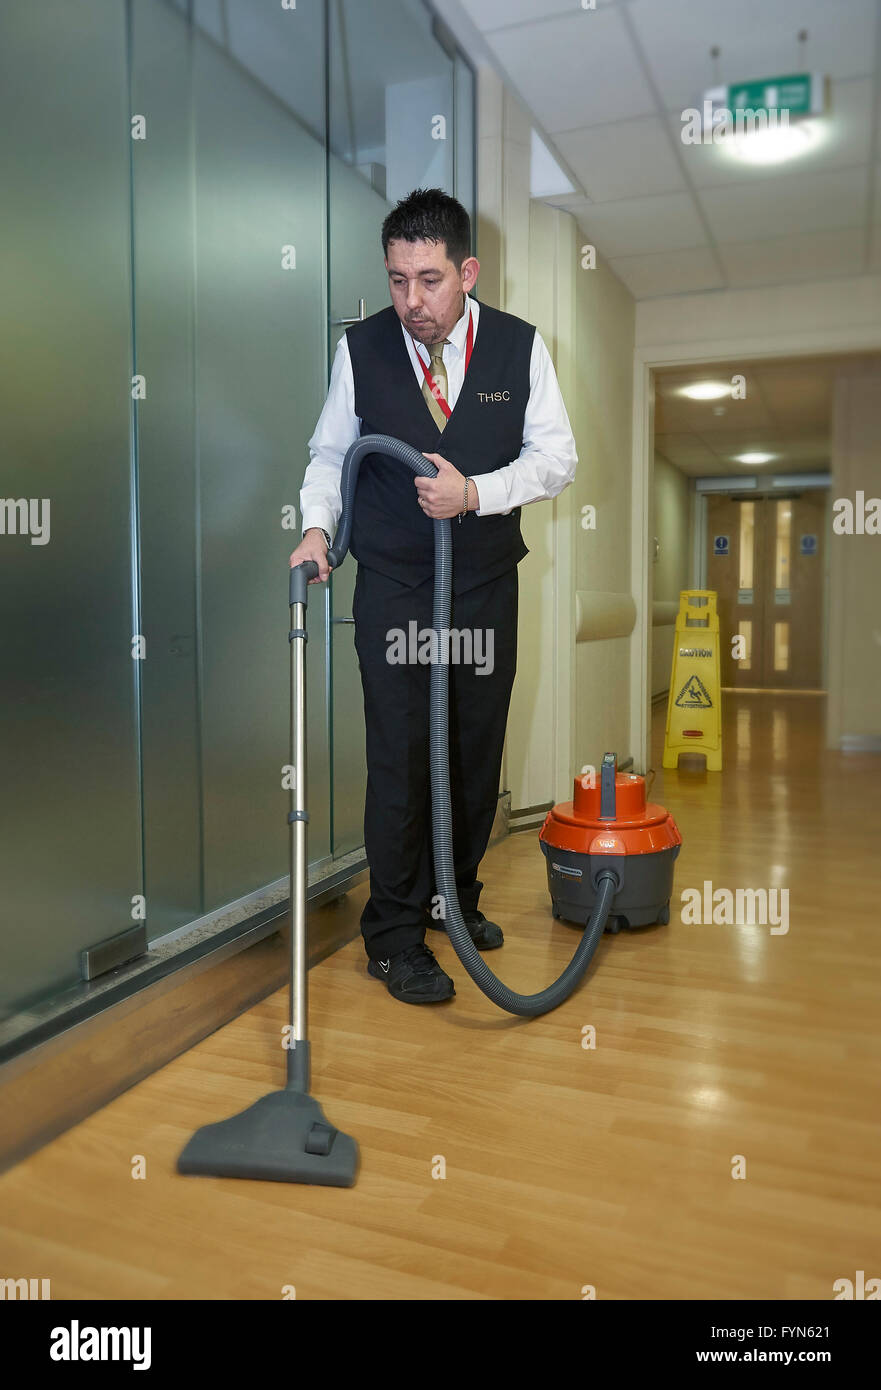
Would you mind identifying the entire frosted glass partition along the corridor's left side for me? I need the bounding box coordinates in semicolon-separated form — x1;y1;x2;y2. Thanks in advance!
0;0;474;1022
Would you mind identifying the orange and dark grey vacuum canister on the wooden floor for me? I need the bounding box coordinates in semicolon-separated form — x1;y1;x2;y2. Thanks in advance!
539;753;682;931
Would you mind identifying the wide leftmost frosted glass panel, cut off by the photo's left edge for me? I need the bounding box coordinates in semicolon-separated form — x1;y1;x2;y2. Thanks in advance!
0;0;142;1012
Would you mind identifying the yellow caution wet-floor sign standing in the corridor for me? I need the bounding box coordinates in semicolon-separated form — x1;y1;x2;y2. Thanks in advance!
664;589;723;773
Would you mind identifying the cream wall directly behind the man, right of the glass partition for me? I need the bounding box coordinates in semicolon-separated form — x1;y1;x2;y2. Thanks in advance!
477;70;635;810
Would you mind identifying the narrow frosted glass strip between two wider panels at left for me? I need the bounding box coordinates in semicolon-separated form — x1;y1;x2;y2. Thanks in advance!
132;0;203;940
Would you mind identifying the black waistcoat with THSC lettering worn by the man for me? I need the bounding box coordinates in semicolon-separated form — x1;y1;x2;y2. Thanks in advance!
347;304;535;594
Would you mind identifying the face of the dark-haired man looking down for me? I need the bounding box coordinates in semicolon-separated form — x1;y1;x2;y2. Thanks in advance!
385;240;479;343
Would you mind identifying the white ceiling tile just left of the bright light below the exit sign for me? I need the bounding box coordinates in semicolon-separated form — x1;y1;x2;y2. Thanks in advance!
554;115;686;203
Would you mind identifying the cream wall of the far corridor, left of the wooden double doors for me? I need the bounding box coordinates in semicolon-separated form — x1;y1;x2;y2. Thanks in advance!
652;456;692;698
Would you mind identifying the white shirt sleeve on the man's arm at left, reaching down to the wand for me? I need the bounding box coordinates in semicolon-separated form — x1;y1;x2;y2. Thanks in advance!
300;334;361;538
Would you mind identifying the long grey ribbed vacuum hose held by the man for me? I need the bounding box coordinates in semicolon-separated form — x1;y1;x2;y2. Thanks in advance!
328;435;618;1017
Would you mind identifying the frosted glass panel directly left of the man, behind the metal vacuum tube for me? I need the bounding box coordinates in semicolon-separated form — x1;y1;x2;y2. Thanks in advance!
193;8;329;910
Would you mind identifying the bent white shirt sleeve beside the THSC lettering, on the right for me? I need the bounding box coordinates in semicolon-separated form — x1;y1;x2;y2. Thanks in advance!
466;328;578;517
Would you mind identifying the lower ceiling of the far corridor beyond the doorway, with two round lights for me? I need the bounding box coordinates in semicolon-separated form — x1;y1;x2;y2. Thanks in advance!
654;354;881;478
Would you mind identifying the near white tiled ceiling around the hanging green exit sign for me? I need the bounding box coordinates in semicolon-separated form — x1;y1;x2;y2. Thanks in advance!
436;0;881;299
